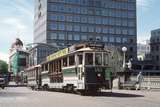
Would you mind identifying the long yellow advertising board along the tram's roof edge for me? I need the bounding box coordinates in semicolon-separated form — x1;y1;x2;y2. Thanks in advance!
47;48;69;61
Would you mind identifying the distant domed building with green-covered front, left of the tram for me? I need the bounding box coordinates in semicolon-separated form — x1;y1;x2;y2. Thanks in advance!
9;38;29;76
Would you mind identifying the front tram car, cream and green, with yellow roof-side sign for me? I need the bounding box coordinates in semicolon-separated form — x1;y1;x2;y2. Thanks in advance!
40;43;111;92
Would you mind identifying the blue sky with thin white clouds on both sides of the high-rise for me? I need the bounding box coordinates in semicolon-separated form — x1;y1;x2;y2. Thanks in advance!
0;0;160;61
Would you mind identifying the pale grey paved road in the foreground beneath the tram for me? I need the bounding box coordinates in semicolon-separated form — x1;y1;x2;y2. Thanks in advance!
0;87;160;107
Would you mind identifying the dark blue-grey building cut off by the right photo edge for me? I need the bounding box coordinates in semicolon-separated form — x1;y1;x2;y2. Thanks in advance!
150;29;160;65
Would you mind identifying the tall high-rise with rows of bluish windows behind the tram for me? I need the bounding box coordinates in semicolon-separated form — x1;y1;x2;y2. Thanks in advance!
34;0;137;61
